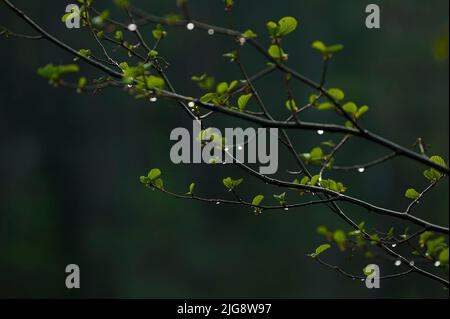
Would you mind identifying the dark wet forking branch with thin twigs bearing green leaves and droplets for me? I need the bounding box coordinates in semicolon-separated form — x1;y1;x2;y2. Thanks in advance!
2;0;449;286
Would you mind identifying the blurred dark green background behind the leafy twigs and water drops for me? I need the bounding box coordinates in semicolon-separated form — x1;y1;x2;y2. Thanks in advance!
0;0;449;298
